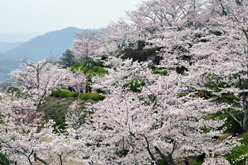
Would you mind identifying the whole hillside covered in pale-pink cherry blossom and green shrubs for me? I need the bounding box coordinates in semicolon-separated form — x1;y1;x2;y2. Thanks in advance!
0;0;248;165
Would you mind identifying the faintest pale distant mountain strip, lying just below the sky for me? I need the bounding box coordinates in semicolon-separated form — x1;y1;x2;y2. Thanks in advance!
0;33;40;42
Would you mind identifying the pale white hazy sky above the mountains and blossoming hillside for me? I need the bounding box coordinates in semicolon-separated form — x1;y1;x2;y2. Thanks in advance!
0;0;143;34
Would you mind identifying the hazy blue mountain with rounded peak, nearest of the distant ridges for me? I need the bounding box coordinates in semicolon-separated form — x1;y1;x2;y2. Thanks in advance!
2;27;82;61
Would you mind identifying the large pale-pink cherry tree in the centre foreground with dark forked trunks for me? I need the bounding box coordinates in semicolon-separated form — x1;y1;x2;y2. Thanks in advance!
87;57;237;164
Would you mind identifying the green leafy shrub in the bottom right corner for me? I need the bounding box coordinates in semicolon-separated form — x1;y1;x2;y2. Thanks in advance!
225;132;248;165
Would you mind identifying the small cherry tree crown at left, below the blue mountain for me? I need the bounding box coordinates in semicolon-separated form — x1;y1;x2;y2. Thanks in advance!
11;60;69;107
